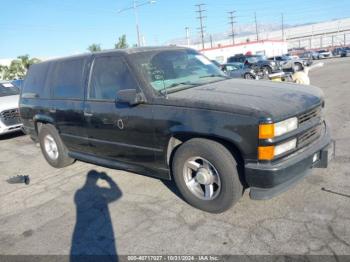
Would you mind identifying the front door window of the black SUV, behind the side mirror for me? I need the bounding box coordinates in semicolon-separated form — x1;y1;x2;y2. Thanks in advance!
89;56;137;100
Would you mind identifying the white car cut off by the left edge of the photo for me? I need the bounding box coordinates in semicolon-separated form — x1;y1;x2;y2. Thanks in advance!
0;81;22;135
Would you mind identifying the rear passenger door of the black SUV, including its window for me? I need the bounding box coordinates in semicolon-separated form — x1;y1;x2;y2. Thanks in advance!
47;57;89;152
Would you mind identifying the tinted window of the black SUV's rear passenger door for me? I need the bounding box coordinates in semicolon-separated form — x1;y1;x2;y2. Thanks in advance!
48;58;85;99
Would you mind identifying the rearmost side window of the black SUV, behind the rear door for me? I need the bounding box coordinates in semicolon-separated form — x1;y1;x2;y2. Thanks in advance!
22;63;50;98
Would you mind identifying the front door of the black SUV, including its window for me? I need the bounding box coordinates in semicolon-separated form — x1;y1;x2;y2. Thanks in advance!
84;55;157;169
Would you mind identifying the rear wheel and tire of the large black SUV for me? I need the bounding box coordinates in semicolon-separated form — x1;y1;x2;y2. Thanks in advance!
39;125;74;168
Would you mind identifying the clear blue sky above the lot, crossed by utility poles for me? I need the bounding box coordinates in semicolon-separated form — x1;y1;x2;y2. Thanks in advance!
0;0;350;58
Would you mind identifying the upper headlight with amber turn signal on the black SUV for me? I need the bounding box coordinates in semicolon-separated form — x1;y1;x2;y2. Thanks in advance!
259;117;298;139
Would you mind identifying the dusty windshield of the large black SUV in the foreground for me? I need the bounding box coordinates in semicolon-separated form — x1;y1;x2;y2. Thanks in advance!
130;49;228;93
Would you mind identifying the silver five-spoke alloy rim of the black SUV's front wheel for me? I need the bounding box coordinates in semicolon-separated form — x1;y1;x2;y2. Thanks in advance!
183;157;221;200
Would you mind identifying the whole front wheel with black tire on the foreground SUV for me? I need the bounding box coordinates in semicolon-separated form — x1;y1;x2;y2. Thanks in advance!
172;138;243;213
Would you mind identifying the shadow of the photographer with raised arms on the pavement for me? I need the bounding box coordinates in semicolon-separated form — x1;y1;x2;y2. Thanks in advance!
70;170;122;261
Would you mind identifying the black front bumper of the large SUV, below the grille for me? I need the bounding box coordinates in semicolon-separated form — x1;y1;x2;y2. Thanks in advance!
245;126;335;199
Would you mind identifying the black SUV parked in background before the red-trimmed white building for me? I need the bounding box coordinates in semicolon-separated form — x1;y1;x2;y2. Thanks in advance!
227;54;282;75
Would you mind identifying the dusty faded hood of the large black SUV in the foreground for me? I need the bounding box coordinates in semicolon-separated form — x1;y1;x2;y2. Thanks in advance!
168;79;323;121
